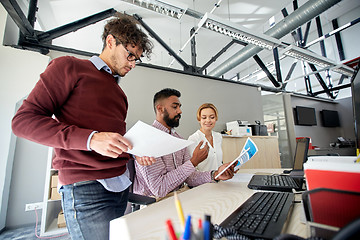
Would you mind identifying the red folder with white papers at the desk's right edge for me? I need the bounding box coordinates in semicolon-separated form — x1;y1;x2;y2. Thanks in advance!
304;158;360;228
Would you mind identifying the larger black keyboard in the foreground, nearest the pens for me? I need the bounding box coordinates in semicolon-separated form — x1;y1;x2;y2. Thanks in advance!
220;192;294;239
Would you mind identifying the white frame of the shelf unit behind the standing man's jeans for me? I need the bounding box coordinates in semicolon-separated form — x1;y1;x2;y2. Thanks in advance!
40;148;67;236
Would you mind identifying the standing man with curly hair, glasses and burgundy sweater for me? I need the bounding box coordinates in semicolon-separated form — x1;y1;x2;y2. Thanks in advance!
12;15;155;240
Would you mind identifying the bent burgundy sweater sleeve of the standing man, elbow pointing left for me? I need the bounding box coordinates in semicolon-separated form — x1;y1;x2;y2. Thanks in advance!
12;57;93;150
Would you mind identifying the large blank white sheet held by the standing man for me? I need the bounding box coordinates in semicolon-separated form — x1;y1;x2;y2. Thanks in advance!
124;121;193;157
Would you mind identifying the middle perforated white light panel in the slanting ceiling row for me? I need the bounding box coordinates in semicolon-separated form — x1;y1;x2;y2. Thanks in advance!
198;13;282;50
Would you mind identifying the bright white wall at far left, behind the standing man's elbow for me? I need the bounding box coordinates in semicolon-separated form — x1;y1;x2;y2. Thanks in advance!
0;5;49;230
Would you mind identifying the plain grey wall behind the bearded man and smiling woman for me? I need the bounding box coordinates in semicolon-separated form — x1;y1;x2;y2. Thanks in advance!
120;66;264;138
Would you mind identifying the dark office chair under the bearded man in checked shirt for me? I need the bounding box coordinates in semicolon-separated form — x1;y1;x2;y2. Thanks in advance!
125;159;156;214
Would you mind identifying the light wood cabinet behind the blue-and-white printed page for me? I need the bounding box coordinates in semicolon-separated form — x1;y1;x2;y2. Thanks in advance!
222;136;281;169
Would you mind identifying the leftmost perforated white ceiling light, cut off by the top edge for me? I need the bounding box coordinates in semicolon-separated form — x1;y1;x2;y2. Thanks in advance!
122;0;187;19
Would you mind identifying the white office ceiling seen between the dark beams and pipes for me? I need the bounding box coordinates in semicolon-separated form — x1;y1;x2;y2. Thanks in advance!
4;0;360;98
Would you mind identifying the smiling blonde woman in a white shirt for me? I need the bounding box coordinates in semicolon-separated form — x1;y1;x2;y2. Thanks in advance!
188;103;222;171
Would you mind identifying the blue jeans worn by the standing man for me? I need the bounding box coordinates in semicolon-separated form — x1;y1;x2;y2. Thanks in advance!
60;181;129;240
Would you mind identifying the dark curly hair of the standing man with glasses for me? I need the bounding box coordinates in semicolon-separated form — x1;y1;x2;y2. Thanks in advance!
102;13;154;59
